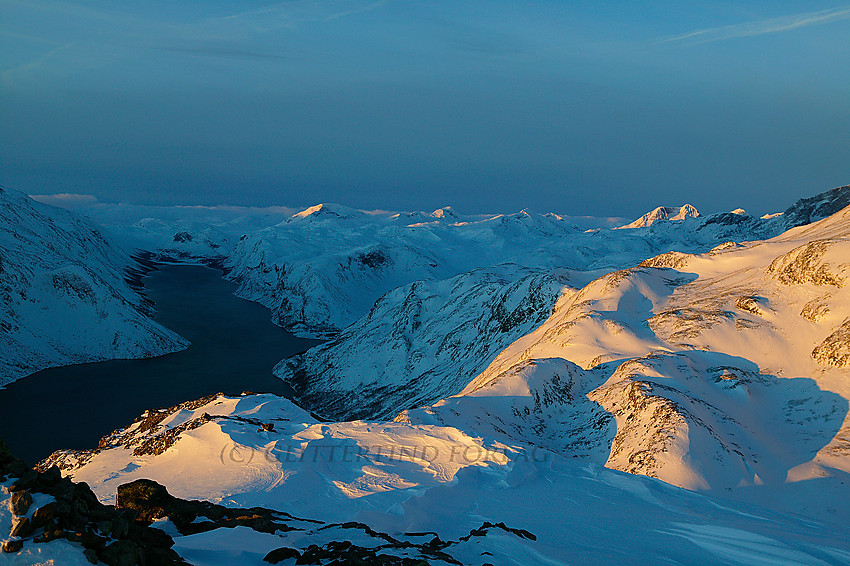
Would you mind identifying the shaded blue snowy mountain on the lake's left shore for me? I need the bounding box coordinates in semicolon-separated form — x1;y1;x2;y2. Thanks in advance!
0;188;186;386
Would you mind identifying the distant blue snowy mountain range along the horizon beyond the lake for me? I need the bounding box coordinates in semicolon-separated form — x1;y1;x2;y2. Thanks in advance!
46;187;850;346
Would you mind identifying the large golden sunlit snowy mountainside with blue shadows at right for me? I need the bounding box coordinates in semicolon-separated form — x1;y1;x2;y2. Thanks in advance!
398;194;850;502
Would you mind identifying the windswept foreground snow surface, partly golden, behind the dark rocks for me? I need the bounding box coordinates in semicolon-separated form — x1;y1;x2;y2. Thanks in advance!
44;395;850;566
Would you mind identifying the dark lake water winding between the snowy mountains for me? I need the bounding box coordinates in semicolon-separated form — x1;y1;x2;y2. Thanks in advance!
0;265;319;464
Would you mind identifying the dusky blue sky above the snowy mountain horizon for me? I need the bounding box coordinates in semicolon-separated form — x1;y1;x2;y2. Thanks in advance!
0;0;850;217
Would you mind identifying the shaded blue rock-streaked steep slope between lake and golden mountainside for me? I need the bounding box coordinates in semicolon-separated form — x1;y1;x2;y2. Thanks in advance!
275;265;573;420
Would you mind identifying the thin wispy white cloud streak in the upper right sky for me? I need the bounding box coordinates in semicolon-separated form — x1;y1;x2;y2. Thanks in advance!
658;6;850;43
